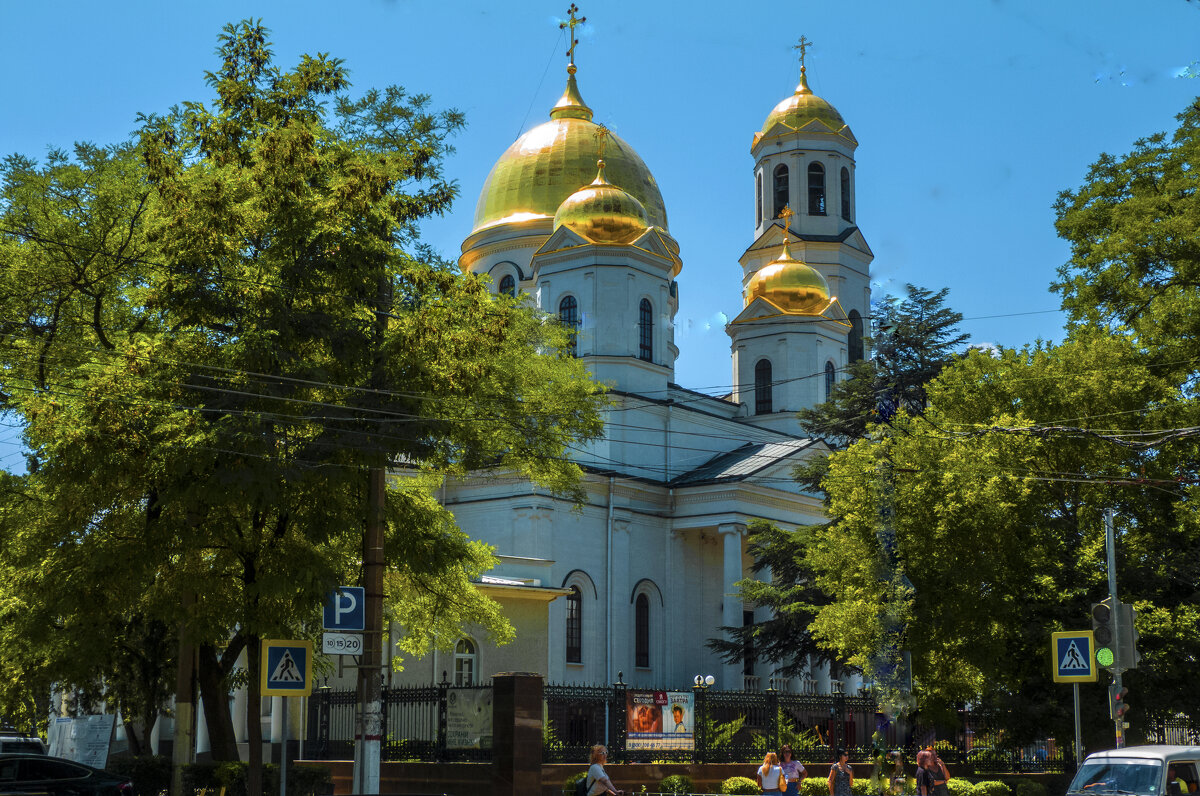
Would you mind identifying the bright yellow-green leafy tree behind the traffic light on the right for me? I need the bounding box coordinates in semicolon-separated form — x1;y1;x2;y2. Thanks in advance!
806;329;1200;736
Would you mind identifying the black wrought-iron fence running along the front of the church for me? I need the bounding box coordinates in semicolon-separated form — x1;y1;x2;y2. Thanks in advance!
305;682;1200;774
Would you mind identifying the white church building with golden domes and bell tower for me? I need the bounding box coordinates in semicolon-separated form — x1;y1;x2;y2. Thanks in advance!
394;37;872;692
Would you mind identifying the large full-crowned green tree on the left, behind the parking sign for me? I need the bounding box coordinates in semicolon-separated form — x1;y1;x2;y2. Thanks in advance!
0;22;601;792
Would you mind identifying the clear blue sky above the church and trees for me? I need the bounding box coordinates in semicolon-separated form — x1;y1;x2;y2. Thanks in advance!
0;0;1200;470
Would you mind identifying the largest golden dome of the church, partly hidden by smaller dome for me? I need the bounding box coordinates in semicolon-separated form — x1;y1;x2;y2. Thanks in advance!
472;65;667;233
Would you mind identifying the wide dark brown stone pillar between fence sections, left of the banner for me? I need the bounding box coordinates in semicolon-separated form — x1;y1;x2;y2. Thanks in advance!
492;671;542;796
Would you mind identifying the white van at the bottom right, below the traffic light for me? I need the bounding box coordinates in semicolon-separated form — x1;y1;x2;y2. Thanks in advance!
1067;746;1200;796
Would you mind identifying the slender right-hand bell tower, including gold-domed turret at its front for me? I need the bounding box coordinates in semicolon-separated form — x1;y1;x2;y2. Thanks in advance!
726;36;874;433
